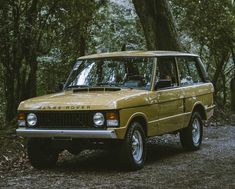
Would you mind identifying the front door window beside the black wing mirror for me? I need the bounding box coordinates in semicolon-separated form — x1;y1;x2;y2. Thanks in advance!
155;57;178;90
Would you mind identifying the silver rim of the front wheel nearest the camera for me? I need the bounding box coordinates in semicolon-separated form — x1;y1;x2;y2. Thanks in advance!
132;130;143;162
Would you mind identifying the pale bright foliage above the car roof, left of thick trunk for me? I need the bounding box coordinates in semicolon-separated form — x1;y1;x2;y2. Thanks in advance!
89;1;146;53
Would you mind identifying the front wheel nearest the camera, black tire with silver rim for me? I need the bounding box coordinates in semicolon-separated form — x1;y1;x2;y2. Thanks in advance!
120;122;146;170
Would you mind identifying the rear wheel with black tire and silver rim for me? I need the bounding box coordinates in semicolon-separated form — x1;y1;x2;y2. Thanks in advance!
180;112;203;151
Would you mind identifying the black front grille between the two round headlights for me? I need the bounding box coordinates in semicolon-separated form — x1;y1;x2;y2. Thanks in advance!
36;112;93;129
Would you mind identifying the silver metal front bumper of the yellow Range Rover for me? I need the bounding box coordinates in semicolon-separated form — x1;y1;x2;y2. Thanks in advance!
16;128;117;139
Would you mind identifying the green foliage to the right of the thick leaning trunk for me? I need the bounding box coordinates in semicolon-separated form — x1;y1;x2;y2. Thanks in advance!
171;0;235;105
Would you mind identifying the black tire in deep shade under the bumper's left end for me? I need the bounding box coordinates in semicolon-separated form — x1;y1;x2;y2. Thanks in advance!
27;139;59;169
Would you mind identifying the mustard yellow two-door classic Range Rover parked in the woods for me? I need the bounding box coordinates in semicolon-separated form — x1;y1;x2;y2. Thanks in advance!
16;51;214;170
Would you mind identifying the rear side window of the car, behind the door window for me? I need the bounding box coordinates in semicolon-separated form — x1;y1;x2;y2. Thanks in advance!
177;57;203;86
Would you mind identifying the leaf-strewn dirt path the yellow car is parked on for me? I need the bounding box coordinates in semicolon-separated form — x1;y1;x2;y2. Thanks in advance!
0;126;235;189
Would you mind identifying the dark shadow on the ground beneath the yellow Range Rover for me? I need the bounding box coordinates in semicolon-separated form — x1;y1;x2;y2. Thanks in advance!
55;137;186;172
